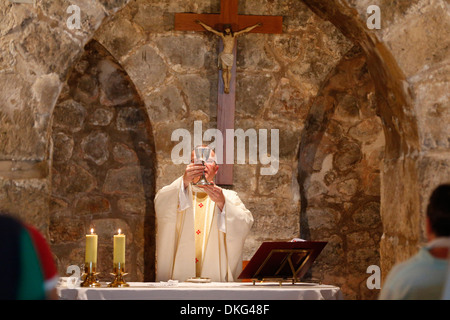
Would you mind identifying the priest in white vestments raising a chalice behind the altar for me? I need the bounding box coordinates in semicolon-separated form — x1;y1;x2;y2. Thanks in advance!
155;150;253;282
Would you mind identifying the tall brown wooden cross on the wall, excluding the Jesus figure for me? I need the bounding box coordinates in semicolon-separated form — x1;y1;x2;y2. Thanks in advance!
175;0;283;185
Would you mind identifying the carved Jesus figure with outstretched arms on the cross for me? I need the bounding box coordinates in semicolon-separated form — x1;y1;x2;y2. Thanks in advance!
195;20;262;93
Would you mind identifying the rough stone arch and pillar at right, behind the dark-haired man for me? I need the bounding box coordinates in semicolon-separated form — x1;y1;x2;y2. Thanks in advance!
303;0;450;284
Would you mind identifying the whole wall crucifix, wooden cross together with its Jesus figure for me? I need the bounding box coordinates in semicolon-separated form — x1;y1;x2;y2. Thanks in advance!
175;0;283;185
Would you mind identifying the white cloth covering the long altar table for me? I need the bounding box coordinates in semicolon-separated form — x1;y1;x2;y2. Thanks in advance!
57;282;343;300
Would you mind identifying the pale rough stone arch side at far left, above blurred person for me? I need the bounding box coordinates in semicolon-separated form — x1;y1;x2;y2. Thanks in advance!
0;0;135;232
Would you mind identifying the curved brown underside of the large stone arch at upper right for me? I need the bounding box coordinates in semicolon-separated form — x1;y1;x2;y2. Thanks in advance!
304;0;419;159
